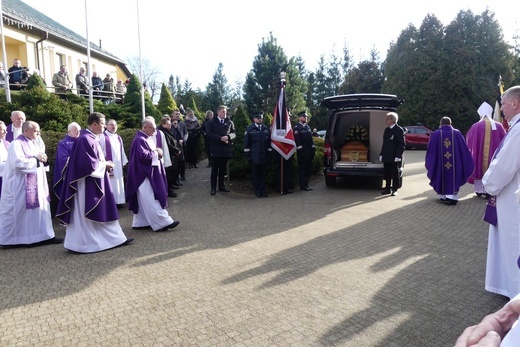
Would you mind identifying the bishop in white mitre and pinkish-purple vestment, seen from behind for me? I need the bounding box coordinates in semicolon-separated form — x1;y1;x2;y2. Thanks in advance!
466;102;506;198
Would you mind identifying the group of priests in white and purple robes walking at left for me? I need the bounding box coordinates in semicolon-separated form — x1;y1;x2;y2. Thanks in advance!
0;111;188;253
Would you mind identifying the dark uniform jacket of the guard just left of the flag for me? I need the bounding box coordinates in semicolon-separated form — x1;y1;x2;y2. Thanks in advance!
244;123;272;164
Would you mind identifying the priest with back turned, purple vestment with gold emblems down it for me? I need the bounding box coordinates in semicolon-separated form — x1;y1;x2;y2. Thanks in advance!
425;117;474;205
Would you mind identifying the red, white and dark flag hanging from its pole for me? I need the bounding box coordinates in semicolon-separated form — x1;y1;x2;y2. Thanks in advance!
271;79;296;160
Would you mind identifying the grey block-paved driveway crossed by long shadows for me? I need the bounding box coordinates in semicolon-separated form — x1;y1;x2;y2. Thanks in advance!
0;151;505;347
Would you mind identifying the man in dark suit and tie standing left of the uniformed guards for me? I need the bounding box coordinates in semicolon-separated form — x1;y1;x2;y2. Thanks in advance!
206;106;236;195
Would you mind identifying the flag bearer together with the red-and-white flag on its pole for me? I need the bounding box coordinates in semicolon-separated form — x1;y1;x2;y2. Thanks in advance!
271;72;296;195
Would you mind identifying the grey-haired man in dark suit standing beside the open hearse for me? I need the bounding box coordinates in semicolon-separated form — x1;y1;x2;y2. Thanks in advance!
379;112;405;196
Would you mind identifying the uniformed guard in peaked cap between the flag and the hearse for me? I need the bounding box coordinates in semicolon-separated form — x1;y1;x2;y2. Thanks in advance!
293;111;316;191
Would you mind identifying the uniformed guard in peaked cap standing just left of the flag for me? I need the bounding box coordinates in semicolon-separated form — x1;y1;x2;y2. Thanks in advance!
244;112;272;198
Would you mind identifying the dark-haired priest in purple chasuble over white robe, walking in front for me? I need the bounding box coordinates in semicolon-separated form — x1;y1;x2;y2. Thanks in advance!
56;112;133;253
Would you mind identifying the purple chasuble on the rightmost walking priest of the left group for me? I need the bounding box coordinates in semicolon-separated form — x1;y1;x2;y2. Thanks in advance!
125;130;168;214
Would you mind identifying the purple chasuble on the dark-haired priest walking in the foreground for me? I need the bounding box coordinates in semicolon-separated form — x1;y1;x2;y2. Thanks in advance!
56;129;119;224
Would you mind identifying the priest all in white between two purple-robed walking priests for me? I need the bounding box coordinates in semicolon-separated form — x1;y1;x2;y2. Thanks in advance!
99;119;128;205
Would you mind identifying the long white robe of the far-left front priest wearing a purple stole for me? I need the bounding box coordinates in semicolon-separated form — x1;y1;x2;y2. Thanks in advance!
0;139;54;245
